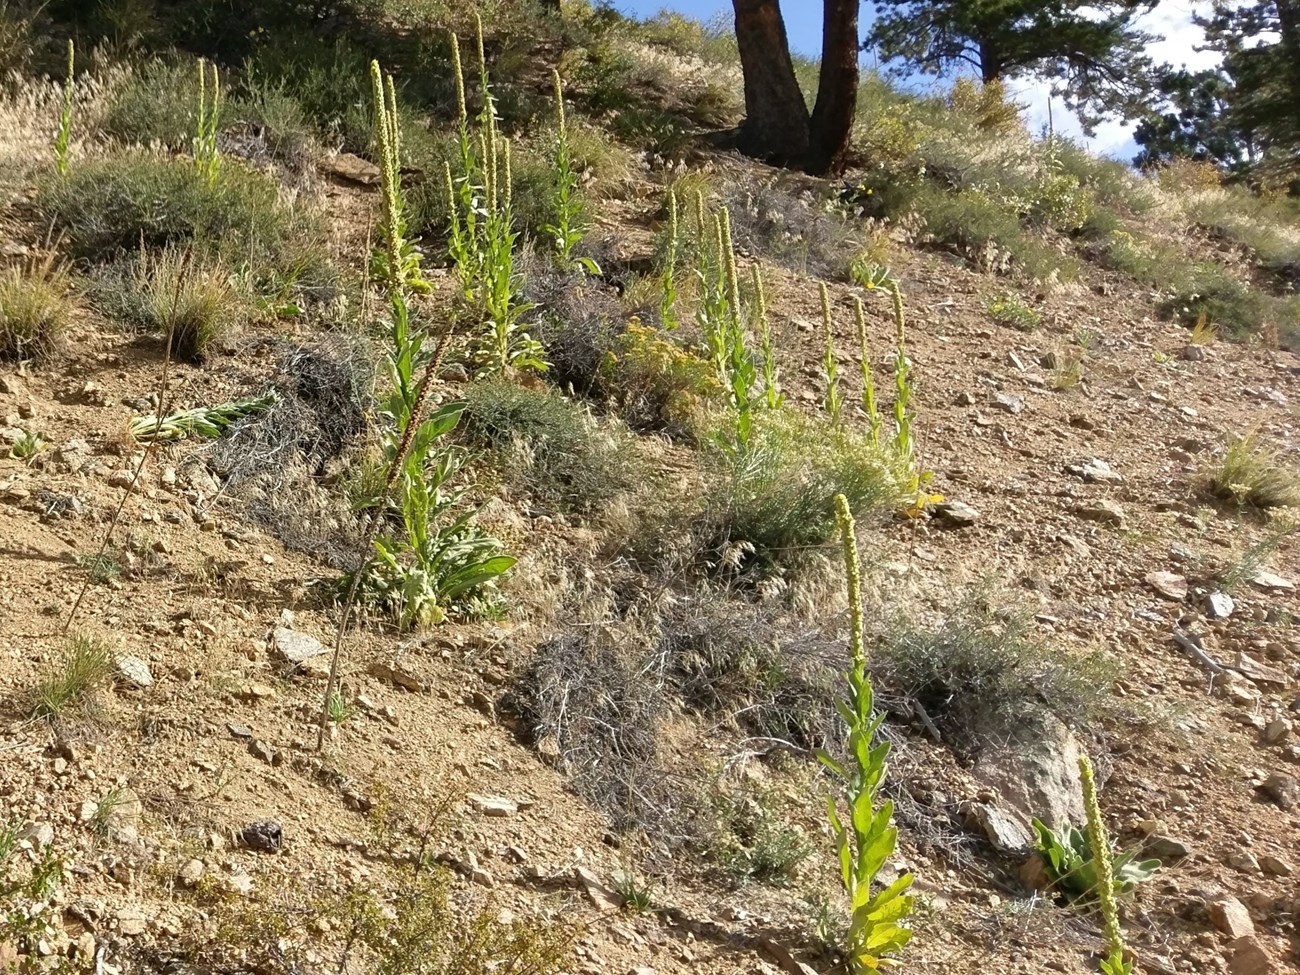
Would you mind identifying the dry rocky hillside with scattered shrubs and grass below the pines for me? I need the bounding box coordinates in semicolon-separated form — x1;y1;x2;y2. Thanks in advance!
0;0;1300;975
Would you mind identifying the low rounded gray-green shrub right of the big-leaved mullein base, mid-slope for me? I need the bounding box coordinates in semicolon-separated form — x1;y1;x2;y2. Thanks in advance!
463;380;644;512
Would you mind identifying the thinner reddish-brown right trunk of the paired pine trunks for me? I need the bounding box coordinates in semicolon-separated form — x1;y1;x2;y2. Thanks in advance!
805;0;861;176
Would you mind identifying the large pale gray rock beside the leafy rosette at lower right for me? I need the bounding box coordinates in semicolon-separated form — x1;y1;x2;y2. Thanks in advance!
972;716;1084;829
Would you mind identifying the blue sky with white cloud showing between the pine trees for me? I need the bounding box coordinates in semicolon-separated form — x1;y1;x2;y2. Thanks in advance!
615;0;1213;160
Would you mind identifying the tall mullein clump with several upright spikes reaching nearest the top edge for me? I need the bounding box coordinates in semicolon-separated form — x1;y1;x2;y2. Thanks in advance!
445;16;549;377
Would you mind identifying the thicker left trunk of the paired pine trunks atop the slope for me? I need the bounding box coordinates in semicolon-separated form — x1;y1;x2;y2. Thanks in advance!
732;0;809;164
